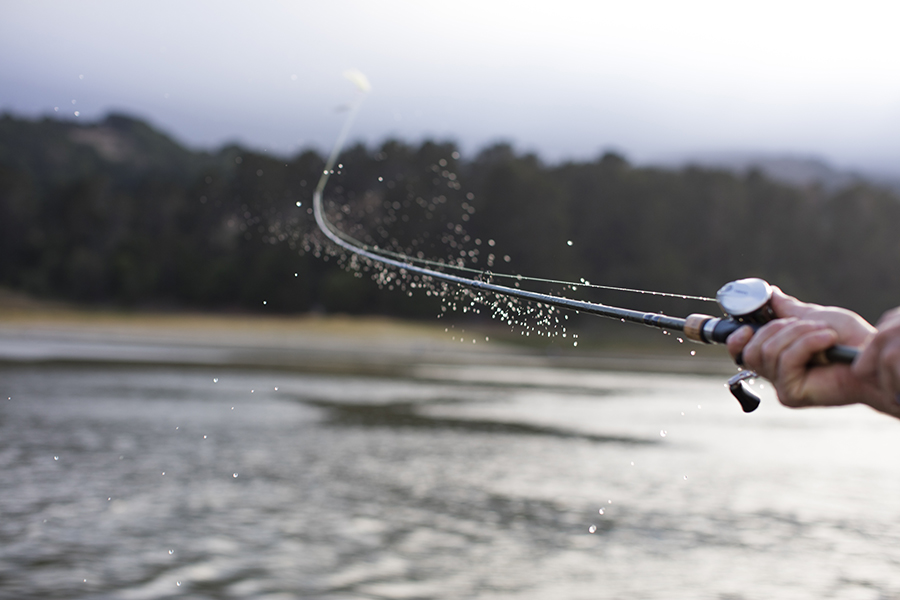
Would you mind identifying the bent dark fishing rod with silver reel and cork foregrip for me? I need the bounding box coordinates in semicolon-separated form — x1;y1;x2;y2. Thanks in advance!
313;72;858;412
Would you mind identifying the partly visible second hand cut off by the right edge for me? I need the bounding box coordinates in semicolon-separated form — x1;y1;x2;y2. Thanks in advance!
851;307;900;412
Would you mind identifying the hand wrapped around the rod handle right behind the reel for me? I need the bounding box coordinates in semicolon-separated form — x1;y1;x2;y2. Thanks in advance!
728;288;884;416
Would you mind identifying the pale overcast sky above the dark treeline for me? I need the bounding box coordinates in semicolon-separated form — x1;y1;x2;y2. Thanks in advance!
0;0;900;173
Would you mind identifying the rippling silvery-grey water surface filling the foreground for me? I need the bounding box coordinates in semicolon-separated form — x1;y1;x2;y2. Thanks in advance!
0;365;900;600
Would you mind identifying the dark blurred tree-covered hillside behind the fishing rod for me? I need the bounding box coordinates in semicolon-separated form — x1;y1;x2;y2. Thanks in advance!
0;115;900;326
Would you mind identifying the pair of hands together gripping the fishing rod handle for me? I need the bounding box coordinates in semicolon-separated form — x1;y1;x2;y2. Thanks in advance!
728;288;900;418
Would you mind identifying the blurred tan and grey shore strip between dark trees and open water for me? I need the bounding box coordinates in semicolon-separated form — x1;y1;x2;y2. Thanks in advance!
0;303;734;376
